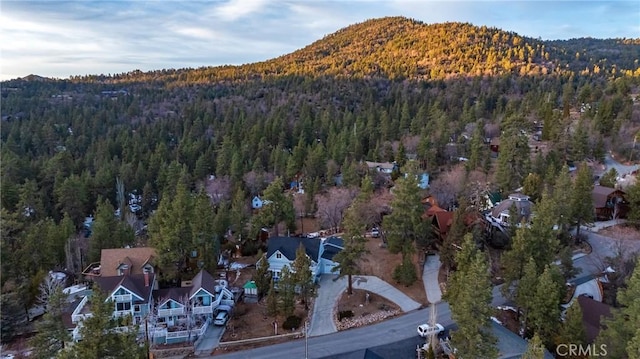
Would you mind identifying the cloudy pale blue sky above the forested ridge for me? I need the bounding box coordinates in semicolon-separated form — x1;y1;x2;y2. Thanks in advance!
0;0;640;80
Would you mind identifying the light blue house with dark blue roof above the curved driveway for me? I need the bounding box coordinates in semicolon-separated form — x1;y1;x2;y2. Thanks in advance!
266;237;343;281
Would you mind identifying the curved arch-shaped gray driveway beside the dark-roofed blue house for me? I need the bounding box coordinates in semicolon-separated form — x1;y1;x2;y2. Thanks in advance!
309;275;421;337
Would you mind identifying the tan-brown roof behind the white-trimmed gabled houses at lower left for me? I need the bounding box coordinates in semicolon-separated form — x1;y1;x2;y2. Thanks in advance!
82;247;157;280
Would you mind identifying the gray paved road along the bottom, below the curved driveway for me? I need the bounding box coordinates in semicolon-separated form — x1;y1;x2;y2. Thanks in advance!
209;302;453;359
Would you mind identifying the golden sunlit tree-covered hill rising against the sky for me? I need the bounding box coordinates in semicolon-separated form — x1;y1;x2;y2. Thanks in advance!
74;17;640;83
